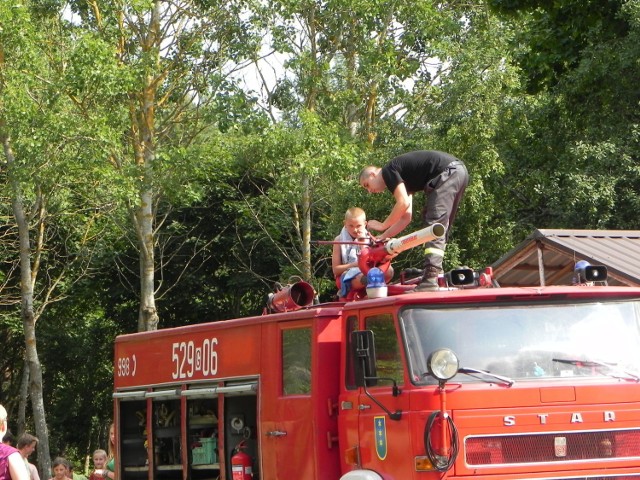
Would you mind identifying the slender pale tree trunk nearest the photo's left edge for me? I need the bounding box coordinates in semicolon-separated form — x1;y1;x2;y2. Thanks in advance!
0;127;51;478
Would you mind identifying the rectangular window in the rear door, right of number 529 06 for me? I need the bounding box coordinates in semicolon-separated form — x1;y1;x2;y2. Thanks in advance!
282;327;311;395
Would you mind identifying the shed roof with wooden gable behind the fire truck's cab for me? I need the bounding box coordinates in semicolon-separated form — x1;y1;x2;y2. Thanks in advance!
491;229;640;287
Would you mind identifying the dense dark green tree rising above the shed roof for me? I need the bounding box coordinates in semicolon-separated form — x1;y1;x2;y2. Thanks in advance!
484;0;640;234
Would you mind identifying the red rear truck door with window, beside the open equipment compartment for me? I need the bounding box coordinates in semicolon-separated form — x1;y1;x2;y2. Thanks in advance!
260;320;316;480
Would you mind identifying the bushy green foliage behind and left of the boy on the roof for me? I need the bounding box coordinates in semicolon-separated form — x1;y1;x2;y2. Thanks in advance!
226;111;358;298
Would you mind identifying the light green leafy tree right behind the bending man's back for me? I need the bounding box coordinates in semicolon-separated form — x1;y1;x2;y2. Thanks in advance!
400;4;520;268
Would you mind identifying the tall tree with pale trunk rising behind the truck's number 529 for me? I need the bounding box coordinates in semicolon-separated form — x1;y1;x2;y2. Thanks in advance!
66;0;262;331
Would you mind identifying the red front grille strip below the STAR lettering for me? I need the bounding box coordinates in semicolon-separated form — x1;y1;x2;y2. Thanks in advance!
465;429;640;464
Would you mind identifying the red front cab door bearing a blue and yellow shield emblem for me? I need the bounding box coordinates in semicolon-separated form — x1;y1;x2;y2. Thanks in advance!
358;314;415;480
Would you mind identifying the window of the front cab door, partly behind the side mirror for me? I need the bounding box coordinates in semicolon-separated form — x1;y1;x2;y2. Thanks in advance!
365;314;404;385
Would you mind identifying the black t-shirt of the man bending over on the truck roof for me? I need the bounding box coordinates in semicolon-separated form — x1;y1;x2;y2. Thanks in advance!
382;150;459;194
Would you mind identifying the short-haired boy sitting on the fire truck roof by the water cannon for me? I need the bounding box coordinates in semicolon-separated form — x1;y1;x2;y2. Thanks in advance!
331;207;393;298
